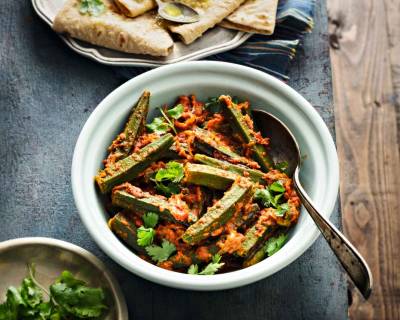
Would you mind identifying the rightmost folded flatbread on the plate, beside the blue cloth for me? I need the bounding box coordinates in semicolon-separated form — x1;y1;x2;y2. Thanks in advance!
220;0;278;34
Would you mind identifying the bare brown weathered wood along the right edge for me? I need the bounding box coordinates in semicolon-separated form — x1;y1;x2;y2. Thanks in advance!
328;0;400;319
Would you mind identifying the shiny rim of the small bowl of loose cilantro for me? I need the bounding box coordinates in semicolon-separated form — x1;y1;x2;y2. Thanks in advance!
0;237;128;320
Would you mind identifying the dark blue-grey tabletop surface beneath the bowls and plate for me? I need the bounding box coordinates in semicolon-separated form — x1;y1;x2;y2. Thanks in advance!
0;0;347;320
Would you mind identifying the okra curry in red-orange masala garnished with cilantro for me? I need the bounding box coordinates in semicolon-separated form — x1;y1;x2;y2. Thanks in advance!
95;91;300;275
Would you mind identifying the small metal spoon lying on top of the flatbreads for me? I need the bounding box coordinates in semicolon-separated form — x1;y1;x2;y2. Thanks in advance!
156;0;200;23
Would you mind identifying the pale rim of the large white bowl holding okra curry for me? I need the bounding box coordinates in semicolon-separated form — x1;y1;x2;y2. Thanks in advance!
71;61;339;290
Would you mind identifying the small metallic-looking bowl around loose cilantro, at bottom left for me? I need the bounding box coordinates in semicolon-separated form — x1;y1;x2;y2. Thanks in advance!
0;238;128;320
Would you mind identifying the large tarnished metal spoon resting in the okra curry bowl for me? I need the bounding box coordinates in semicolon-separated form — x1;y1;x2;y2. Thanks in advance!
253;110;372;299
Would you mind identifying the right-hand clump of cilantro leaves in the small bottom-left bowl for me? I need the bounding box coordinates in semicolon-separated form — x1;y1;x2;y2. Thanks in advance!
50;271;107;319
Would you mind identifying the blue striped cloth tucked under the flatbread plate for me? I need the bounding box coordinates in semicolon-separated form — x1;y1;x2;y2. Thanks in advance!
117;0;315;80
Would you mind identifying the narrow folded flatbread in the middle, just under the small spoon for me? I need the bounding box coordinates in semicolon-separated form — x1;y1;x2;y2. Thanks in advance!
169;0;245;44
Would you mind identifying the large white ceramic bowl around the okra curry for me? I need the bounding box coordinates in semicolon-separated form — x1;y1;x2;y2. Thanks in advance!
72;61;339;290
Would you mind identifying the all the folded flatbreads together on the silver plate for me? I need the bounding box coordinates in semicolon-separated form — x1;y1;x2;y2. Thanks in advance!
53;0;278;56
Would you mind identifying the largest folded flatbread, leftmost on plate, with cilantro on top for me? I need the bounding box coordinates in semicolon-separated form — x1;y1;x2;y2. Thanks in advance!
53;0;174;56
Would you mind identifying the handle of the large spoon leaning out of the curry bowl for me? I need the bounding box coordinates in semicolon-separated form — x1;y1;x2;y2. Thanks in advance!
293;167;373;299
